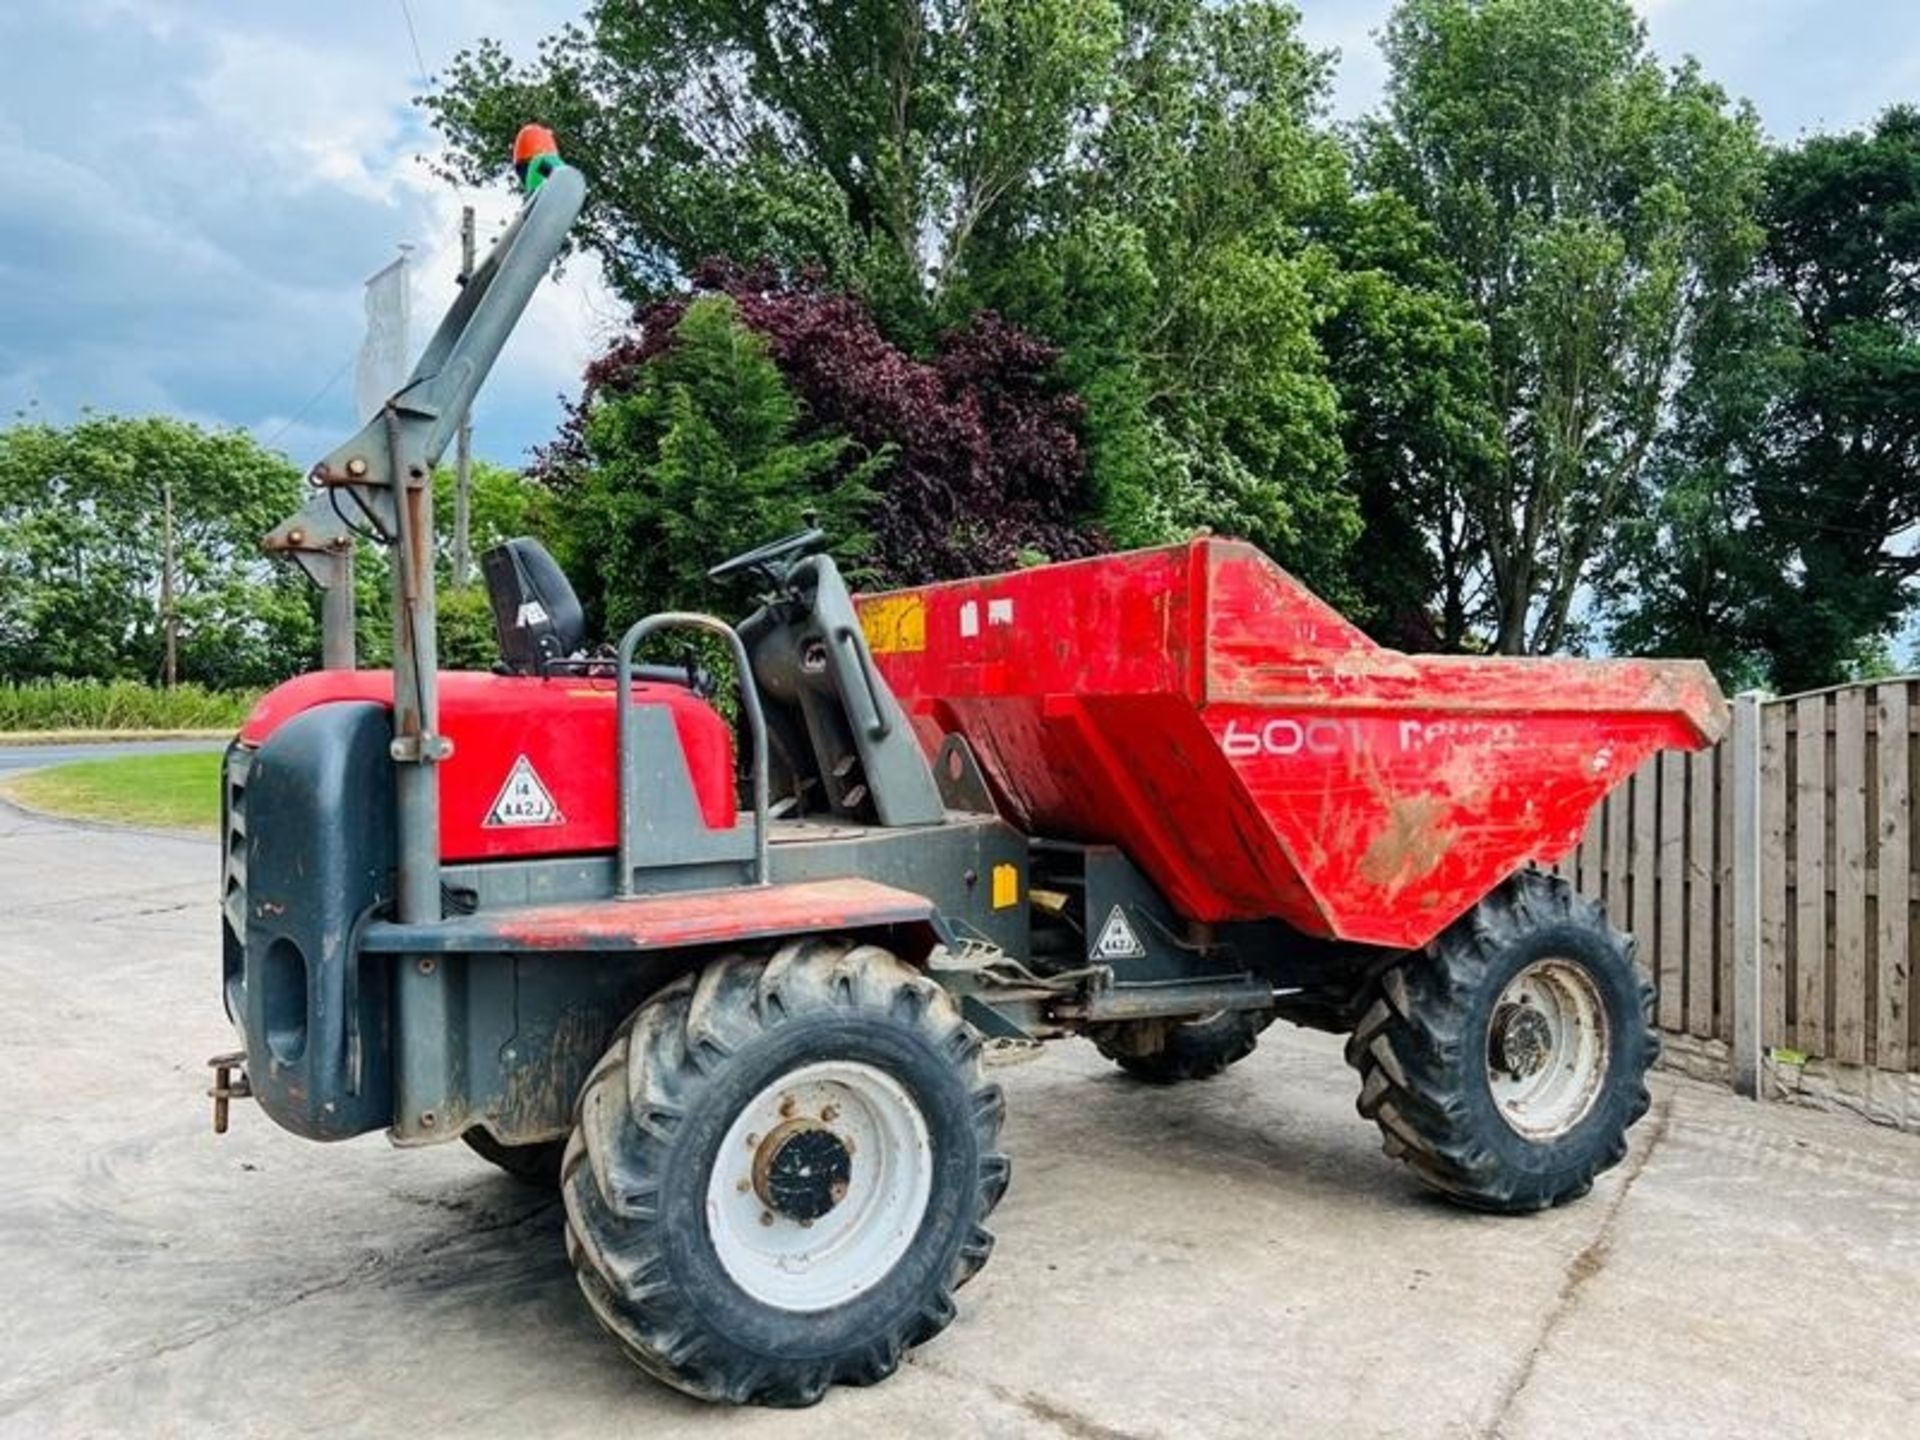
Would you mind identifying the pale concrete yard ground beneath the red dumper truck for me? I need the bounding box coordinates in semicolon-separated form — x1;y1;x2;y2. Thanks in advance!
0;808;1920;1440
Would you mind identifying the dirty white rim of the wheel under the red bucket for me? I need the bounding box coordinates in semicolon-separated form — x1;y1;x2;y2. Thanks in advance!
1486;956;1609;1140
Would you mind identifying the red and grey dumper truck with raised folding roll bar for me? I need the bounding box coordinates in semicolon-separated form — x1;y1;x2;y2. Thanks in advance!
215;157;1724;1405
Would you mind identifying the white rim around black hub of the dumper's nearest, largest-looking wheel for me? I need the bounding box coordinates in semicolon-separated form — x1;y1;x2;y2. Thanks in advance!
707;1060;933;1311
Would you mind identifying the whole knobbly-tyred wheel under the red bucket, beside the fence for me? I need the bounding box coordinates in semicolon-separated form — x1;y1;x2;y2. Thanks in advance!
1346;872;1659;1213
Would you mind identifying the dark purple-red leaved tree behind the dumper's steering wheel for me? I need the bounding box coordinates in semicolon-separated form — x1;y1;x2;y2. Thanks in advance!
536;261;1106;584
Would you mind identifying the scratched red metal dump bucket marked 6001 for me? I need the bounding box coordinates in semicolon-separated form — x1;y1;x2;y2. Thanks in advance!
860;540;1726;947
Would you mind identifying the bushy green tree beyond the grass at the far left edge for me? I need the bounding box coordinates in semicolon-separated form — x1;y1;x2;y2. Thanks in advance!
0;415;317;687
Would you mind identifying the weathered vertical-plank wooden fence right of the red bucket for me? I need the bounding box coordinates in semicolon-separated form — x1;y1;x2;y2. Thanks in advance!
1505;680;1920;1071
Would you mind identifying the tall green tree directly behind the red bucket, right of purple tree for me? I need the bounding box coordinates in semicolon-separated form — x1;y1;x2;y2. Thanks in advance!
966;0;1359;599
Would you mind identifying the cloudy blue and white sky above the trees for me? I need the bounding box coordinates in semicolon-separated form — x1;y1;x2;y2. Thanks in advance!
0;0;1920;474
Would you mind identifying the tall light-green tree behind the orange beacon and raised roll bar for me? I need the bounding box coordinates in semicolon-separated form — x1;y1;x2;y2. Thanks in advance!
424;0;1119;336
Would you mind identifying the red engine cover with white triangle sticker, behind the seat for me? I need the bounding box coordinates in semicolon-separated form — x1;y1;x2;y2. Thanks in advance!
240;670;737;862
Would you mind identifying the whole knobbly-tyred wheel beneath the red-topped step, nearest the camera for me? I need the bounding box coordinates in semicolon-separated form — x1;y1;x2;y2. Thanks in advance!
561;939;1008;1405
